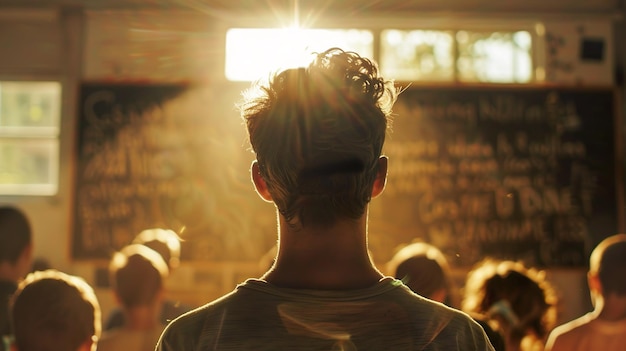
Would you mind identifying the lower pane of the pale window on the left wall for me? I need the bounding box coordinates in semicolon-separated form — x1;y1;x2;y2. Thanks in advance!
0;138;59;195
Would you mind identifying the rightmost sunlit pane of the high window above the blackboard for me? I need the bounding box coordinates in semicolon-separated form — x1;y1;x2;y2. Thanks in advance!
456;31;532;83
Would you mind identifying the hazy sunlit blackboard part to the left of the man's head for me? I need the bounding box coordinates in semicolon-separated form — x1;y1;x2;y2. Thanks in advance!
72;83;276;261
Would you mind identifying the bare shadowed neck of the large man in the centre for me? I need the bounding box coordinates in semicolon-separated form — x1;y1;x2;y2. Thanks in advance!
262;216;383;290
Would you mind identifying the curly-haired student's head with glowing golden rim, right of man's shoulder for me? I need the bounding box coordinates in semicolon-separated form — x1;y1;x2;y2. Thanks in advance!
463;259;556;340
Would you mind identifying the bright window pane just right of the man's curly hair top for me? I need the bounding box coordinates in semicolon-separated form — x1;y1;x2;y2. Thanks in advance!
380;30;454;81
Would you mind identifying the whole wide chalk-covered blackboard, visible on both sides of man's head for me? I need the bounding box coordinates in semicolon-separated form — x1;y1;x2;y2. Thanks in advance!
72;83;622;267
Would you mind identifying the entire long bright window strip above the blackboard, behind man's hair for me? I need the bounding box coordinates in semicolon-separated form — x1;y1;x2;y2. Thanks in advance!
226;28;541;83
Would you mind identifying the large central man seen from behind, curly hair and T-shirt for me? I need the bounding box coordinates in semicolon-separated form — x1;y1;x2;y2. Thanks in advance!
157;48;492;351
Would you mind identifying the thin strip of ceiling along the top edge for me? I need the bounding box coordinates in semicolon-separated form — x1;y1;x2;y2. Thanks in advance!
0;0;624;16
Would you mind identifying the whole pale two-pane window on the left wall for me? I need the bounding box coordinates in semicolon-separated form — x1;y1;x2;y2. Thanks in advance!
0;81;61;195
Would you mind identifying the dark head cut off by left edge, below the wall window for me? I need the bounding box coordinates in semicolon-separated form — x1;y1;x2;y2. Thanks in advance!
0;207;32;264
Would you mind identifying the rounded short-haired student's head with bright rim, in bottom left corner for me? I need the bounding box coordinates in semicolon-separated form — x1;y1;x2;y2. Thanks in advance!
11;270;101;351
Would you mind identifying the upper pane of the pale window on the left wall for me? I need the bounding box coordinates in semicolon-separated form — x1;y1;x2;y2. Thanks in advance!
0;82;61;136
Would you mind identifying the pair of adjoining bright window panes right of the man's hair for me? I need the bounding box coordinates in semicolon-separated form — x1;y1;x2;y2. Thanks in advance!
380;29;533;83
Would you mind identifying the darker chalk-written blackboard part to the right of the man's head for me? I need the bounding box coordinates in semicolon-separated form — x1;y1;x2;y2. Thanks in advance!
370;86;622;267
